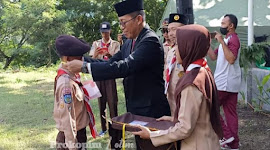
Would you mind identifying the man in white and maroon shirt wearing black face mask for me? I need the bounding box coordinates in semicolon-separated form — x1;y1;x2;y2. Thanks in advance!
208;14;241;150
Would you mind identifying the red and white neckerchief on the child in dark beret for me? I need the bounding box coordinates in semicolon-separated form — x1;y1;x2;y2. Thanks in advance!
55;69;98;138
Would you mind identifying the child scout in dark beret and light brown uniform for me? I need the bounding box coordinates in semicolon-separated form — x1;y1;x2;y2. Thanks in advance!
53;35;96;150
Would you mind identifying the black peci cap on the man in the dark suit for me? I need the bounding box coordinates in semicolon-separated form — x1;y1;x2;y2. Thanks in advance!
114;0;144;17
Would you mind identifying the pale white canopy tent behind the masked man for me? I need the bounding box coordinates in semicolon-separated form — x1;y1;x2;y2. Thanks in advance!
158;0;270;45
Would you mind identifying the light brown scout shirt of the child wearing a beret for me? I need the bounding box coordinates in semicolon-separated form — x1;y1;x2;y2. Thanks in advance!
53;65;89;149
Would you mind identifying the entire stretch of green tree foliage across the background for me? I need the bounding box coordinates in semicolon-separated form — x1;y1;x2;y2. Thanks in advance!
0;0;168;68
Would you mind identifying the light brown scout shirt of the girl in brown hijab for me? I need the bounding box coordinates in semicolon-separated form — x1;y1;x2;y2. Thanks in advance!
150;69;220;150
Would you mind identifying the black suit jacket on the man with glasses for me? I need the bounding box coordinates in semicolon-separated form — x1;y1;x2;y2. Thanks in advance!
85;25;170;118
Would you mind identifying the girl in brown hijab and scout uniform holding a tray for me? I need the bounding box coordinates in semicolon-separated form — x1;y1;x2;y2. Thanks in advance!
133;25;223;150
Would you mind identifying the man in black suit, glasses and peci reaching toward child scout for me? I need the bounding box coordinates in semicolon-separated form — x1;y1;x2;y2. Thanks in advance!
66;0;170;148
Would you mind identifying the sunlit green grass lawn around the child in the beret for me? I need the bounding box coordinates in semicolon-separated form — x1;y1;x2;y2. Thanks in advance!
0;67;130;150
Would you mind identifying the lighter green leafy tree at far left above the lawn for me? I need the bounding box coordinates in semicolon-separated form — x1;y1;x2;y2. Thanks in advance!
0;0;70;69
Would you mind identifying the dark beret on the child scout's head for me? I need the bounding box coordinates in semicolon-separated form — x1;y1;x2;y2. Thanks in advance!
55;35;90;57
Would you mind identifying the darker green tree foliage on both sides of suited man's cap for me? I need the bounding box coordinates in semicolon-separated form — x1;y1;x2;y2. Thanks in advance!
59;0;168;43
